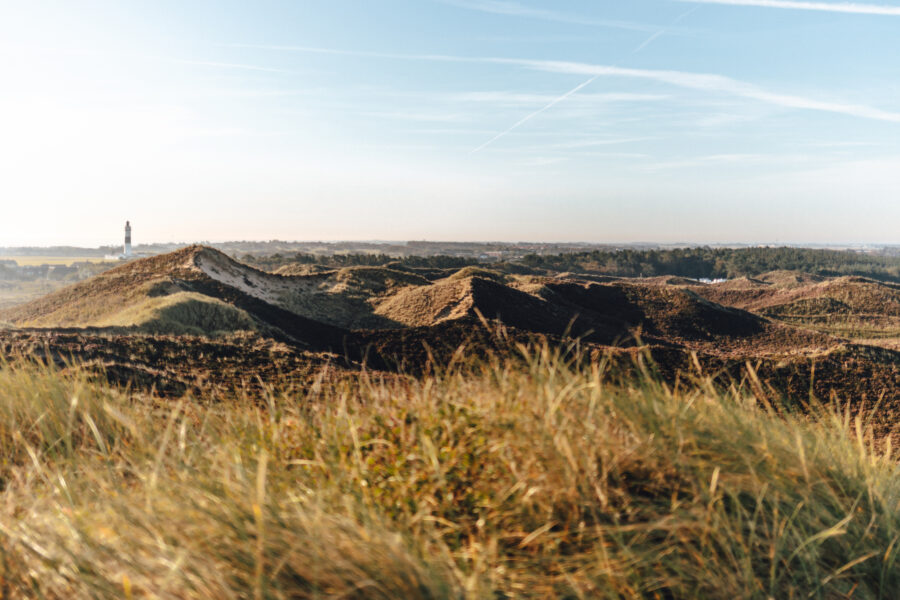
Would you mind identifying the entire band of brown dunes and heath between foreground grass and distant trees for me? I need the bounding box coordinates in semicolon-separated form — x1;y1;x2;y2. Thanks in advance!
0;246;900;404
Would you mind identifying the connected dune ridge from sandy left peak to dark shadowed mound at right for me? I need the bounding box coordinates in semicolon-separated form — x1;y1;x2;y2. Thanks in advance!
0;246;804;352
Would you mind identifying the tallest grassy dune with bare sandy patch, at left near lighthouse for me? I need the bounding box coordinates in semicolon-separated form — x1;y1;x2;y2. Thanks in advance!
0;246;344;349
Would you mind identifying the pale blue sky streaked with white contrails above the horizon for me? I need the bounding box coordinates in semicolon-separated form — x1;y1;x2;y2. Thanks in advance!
0;0;900;247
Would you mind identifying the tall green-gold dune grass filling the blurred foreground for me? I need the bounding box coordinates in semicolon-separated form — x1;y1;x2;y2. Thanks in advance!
0;348;900;599
